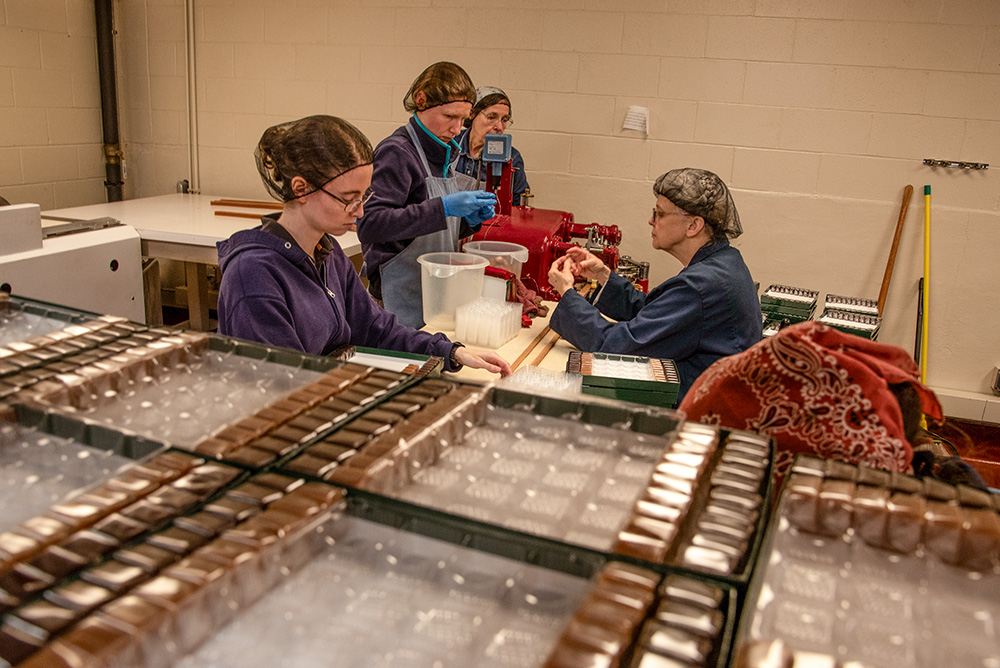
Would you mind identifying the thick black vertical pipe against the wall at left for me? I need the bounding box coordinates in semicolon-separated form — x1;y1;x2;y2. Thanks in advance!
94;0;124;202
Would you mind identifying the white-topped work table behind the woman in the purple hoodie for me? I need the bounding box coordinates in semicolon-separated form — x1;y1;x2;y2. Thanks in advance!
42;193;361;330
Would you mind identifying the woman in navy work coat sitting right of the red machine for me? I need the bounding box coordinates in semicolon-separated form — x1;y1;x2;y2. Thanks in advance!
549;169;761;401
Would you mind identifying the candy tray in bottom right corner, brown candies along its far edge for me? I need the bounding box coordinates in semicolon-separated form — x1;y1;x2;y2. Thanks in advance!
743;457;1000;667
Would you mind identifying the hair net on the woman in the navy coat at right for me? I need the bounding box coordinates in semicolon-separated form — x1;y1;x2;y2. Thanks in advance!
653;167;743;240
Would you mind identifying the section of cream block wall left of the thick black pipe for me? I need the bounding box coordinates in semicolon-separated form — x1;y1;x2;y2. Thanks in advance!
0;0;104;209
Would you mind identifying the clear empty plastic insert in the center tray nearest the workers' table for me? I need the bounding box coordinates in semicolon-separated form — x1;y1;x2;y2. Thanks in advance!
382;392;670;551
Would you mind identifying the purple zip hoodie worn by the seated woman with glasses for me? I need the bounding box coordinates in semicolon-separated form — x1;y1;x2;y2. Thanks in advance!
216;217;453;370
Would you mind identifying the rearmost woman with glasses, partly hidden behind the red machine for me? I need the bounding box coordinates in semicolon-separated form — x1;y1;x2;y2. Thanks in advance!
455;86;528;206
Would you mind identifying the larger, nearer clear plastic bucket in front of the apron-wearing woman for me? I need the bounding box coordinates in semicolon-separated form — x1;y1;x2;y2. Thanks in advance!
417;253;489;330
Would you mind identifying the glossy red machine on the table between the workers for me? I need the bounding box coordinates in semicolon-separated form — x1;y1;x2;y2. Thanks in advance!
472;155;622;301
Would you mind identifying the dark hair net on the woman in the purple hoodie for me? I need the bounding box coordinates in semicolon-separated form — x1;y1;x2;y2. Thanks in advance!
254;116;372;202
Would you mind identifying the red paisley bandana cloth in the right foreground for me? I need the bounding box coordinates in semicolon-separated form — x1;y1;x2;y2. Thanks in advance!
680;321;941;482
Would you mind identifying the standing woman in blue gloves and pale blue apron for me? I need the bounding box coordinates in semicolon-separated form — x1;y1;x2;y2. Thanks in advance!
358;62;496;328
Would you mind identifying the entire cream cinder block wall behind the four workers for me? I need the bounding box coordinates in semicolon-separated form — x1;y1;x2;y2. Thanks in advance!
0;0;1000;402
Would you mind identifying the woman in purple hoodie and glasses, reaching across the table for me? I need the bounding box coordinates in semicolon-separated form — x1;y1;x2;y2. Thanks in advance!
217;116;510;375
